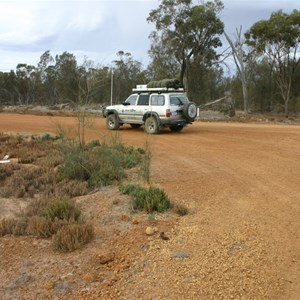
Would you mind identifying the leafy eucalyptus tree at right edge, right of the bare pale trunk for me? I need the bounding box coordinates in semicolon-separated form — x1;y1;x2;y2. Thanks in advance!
245;10;300;116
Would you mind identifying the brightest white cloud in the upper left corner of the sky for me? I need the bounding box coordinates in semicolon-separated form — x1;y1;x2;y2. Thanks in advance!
0;1;105;51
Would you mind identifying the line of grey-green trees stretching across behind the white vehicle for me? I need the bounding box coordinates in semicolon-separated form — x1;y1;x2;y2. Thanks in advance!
0;0;300;115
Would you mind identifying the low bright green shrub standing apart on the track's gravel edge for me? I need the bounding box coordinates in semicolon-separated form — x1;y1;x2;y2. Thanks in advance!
120;184;171;213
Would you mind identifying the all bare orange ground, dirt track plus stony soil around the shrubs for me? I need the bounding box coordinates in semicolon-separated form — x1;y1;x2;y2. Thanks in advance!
0;113;300;299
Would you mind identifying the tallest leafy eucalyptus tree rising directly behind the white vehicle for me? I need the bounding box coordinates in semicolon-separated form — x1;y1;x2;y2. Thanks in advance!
147;0;224;89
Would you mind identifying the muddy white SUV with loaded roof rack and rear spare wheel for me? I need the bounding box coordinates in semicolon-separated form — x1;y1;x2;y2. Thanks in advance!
103;85;197;134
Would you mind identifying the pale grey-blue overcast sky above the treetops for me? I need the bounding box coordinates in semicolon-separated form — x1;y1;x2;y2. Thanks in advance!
0;0;300;72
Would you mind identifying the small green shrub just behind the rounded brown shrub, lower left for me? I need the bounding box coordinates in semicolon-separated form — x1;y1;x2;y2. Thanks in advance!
39;199;81;221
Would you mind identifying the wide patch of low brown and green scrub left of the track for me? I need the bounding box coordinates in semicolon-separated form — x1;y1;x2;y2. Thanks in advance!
0;134;144;252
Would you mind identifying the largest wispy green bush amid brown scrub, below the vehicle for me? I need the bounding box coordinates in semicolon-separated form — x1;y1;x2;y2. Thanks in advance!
59;137;142;186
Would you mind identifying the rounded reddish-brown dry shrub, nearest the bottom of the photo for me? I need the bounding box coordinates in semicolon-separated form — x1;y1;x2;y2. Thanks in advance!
52;223;94;252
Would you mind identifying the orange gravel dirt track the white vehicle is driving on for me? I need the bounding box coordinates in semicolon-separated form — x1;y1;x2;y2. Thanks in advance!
0;114;300;299
